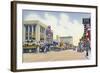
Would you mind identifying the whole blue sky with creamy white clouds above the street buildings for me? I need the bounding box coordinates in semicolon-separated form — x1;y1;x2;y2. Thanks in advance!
22;10;91;46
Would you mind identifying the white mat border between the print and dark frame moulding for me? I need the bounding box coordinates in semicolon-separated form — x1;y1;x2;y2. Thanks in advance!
16;4;96;69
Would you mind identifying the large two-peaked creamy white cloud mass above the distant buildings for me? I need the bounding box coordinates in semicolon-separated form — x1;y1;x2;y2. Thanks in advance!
45;13;84;45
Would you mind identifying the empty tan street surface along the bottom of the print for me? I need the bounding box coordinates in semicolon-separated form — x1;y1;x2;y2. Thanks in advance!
23;50;86;62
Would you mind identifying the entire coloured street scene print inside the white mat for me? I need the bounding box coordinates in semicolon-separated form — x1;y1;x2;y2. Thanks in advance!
22;9;91;63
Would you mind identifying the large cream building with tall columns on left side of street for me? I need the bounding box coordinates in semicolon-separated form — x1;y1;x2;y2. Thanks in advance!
22;20;47;42
